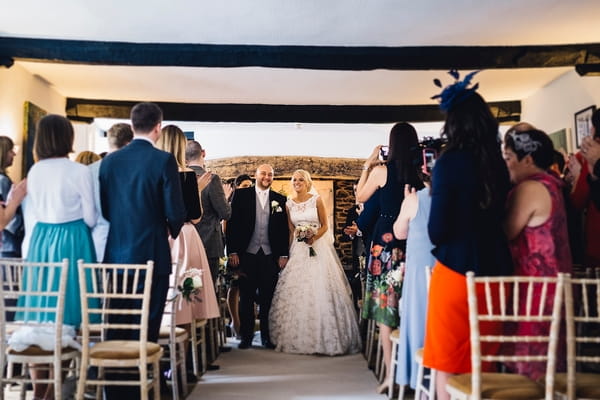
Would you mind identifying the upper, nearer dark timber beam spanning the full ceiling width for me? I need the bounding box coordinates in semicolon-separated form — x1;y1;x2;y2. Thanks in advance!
0;37;600;71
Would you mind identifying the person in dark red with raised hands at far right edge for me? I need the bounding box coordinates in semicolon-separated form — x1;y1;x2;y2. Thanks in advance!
568;109;600;267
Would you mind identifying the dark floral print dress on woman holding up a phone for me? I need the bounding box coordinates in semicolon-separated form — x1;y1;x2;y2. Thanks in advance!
362;168;406;328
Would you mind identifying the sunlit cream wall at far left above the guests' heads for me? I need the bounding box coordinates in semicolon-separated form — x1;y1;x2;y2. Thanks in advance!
0;65;66;181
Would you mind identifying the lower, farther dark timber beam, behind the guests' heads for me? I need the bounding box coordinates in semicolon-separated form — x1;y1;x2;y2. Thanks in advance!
66;98;521;123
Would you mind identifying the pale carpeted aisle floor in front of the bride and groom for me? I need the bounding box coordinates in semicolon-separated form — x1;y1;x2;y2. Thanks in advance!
187;341;386;400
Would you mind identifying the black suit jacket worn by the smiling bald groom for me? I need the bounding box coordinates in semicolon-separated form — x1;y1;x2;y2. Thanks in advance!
226;187;289;260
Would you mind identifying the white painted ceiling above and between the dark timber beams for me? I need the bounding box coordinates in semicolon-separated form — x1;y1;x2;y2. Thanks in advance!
0;0;600;159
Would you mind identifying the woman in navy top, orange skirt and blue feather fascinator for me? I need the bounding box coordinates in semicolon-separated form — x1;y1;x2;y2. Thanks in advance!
423;71;512;400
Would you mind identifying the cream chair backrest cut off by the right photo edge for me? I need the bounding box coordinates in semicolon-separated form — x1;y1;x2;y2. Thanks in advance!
565;274;600;399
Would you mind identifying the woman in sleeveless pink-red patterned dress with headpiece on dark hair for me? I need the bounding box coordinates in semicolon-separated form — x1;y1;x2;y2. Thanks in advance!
504;128;572;380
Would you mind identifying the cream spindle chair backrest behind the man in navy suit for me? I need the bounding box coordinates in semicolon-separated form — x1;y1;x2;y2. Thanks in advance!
78;260;154;356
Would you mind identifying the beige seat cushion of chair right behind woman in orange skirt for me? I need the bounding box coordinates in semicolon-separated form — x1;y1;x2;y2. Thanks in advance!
448;373;544;400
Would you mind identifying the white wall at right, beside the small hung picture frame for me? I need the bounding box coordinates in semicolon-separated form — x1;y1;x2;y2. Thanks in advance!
521;70;600;151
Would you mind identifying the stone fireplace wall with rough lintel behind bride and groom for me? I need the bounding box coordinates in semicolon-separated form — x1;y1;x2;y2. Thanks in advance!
206;156;364;268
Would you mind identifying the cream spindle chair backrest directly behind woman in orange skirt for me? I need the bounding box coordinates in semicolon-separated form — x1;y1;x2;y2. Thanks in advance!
467;272;568;399
